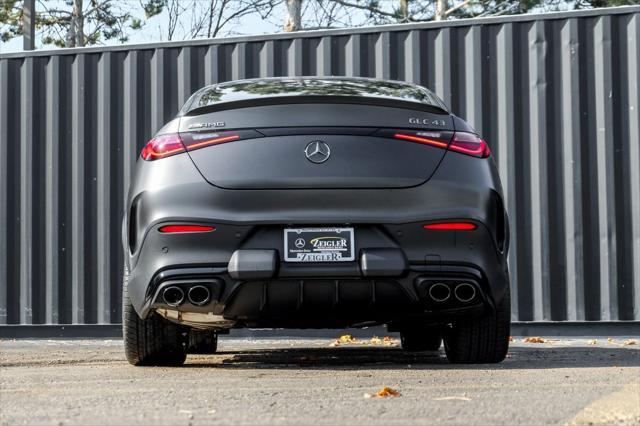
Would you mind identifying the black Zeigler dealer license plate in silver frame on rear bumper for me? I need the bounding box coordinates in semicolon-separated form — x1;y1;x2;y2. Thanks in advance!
284;228;355;262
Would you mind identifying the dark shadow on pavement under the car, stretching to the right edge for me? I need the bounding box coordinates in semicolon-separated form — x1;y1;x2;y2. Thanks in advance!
184;346;640;370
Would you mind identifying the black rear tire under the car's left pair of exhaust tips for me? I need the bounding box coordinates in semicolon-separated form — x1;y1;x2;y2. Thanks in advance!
122;270;188;366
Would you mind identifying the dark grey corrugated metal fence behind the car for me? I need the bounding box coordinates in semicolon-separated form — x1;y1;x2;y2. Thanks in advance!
0;7;640;324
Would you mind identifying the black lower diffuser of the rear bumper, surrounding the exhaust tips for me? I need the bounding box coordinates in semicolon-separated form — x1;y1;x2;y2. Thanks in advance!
144;265;500;328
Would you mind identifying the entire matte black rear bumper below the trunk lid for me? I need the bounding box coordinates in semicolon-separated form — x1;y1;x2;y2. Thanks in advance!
123;153;509;327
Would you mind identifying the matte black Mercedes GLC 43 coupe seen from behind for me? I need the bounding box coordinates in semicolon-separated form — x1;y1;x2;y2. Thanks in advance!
122;77;510;365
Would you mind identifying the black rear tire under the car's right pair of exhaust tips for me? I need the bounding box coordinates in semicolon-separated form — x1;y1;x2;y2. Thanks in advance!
444;290;511;364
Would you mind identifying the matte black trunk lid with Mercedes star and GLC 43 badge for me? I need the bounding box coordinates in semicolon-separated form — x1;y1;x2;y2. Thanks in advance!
180;104;453;189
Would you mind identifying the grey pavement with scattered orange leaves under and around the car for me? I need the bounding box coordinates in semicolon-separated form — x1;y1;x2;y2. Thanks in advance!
0;336;640;425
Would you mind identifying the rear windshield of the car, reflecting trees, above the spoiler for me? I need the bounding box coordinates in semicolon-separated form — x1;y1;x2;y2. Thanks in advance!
180;77;447;115
